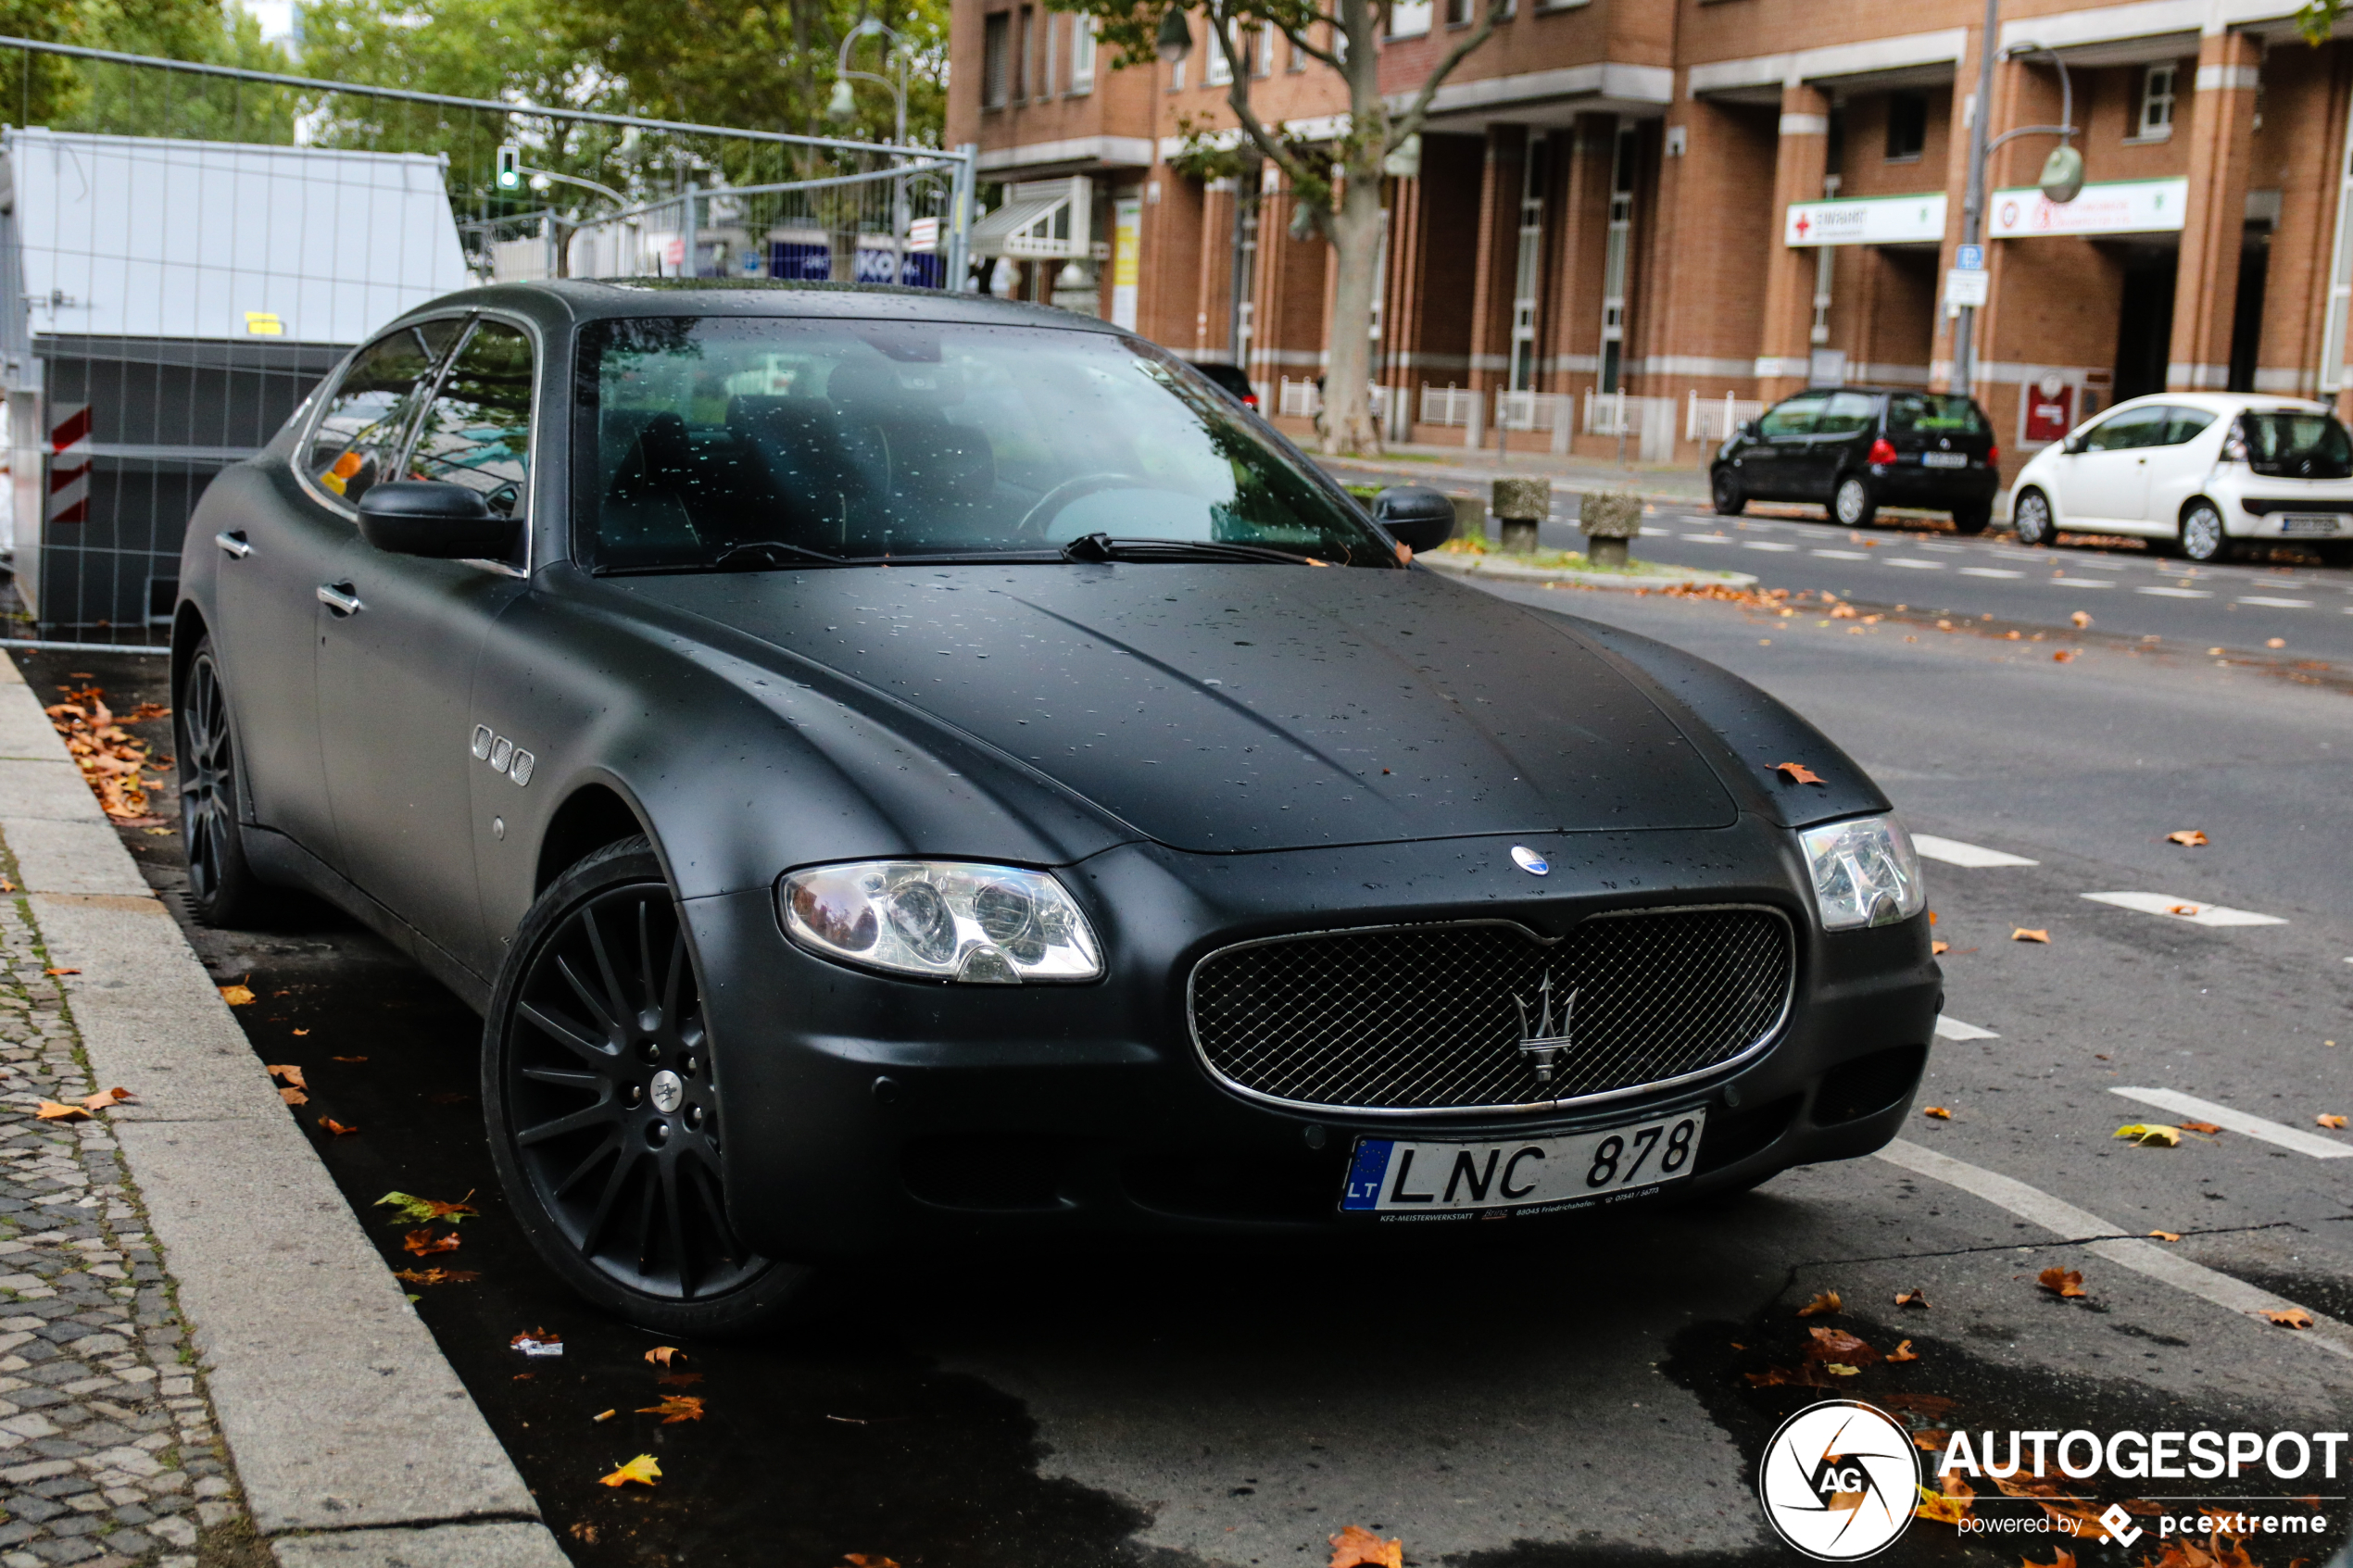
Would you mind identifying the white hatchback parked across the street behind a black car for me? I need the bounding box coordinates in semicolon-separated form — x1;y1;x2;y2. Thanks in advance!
2009;393;2353;567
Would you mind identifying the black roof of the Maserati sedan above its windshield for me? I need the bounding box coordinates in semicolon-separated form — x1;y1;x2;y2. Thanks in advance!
381;278;1120;333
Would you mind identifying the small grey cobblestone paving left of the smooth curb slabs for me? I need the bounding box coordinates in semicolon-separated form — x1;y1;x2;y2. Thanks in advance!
0;846;252;1568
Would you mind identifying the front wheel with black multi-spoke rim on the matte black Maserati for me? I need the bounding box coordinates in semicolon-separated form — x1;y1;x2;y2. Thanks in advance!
483;837;814;1336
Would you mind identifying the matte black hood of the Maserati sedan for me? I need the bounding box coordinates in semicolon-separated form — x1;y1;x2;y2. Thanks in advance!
607;562;1737;851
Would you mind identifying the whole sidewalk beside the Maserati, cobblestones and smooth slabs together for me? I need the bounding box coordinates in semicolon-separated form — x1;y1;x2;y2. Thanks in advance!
0;659;565;1568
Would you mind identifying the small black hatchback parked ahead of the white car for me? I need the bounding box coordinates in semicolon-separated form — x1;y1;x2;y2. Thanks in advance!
1708;388;2003;533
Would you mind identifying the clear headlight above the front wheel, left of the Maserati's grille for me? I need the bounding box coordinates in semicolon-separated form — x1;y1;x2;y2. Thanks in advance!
776;860;1103;985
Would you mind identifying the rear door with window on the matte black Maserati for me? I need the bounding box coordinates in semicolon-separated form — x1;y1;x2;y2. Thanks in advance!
212;322;457;868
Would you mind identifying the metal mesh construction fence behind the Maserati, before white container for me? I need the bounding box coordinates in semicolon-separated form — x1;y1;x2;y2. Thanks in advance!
0;38;975;644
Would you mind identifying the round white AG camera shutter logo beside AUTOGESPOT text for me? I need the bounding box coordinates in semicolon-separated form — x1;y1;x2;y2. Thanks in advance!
1757;1399;1920;1563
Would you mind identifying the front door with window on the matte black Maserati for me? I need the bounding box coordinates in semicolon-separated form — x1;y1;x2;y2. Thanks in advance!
318;318;536;973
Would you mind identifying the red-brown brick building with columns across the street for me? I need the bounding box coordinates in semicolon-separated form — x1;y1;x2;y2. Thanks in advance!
949;0;2353;463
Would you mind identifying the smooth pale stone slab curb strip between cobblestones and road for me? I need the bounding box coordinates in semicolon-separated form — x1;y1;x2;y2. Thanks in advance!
0;659;567;1568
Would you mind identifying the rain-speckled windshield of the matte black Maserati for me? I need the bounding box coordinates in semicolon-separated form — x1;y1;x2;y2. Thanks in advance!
576;318;1398;569
